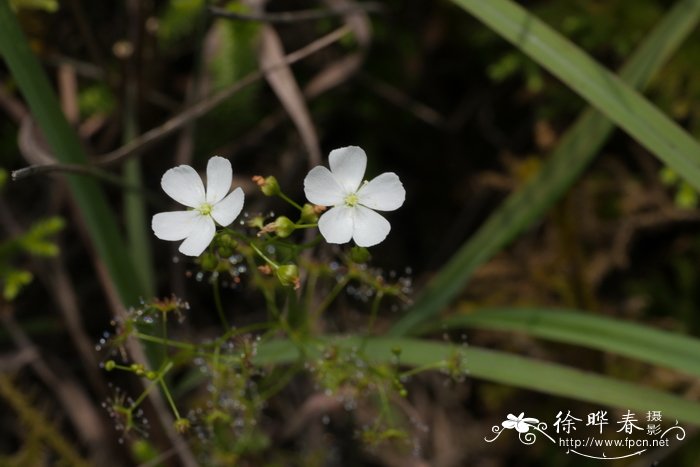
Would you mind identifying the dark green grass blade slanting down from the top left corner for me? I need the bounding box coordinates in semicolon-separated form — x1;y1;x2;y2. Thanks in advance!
0;0;141;305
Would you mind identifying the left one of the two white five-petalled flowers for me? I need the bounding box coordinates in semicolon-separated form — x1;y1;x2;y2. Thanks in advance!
151;156;243;256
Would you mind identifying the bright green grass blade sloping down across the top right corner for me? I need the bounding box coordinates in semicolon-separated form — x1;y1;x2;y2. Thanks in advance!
453;0;700;185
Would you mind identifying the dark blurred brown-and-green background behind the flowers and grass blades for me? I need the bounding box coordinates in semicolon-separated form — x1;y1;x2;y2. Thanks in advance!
0;0;700;467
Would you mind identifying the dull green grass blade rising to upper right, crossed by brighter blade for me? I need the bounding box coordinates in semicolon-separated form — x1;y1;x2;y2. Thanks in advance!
391;0;700;335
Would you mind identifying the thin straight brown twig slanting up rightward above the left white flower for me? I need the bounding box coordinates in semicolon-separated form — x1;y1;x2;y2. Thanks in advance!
97;26;350;165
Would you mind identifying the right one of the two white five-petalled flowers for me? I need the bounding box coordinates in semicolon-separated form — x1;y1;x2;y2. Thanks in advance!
304;146;406;246
